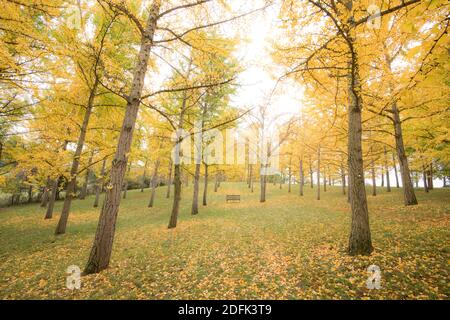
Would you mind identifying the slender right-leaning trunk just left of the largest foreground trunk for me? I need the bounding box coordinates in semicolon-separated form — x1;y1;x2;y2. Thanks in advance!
55;80;98;235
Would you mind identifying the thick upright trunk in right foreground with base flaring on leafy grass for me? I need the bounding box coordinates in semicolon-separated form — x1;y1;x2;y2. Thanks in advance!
348;43;373;255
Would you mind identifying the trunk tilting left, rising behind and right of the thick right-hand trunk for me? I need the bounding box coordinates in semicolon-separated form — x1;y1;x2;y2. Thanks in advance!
392;102;417;206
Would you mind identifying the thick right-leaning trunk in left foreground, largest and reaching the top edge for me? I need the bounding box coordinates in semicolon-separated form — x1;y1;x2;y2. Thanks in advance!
84;1;161;274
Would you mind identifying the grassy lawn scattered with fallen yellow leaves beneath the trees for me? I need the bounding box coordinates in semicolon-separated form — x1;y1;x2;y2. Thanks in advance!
0;183;450;299
